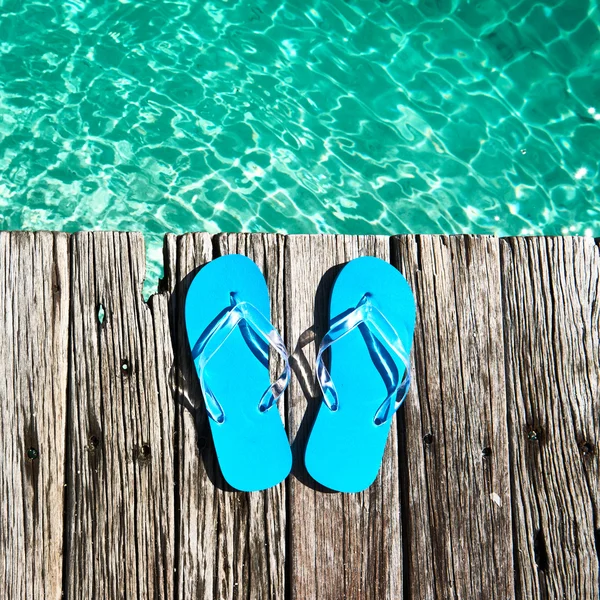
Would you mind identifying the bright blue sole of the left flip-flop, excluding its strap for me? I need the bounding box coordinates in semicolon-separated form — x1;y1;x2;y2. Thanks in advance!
185;254;292;491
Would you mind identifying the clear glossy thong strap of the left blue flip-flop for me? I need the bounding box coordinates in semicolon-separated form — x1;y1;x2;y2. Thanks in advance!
192;293;291;424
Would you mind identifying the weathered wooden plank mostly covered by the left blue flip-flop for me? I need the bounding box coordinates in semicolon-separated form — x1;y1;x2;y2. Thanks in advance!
171;234;285;600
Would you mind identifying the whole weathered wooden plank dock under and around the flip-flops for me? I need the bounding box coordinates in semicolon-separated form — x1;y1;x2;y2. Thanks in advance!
0;232;600;600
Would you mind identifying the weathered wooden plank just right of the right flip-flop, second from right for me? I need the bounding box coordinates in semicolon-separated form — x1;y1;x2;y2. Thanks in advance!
392;236;513;600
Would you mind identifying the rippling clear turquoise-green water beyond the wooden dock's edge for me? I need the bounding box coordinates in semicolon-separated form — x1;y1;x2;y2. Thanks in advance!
0;0;600;292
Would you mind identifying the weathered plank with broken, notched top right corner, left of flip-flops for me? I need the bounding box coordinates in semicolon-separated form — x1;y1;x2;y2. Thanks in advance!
66;233;175;599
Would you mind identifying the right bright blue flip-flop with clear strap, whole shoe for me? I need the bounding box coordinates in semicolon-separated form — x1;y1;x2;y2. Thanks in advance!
305;257;415;492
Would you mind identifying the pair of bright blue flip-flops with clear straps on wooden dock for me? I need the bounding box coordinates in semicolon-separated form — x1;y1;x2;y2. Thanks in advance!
185;254;415;492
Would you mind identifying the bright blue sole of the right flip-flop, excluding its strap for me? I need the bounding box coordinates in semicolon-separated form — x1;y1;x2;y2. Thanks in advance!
305;257;415;492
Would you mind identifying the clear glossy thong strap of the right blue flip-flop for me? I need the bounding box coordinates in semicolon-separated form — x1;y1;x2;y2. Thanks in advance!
317;294;410;425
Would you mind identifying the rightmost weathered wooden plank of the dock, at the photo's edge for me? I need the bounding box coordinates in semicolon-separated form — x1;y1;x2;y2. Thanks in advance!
501;238;600;600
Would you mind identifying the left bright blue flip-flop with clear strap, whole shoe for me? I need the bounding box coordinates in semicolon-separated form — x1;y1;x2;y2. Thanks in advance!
185;254;292;492
